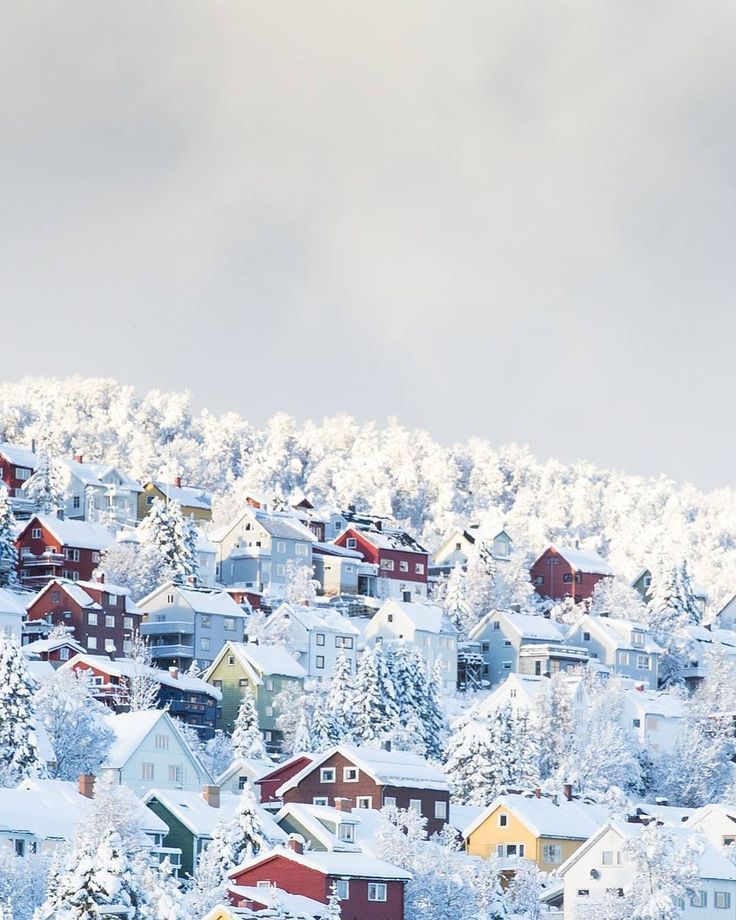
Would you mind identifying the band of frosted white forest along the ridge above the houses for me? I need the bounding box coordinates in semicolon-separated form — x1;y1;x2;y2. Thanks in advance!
0;377;736;609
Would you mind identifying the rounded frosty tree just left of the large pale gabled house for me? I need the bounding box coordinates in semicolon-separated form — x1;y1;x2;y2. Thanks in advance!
35;671;115;780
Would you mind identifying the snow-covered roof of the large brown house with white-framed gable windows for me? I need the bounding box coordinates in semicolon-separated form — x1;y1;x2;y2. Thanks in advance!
276;744;450;796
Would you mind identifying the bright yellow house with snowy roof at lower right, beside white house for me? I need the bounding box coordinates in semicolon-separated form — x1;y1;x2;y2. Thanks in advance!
463;786;608;872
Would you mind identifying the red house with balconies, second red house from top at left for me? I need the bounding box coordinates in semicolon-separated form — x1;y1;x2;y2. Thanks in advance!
15;514;115;588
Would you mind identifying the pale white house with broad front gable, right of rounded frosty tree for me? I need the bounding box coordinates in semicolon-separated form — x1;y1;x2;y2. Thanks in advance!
100;709;212;796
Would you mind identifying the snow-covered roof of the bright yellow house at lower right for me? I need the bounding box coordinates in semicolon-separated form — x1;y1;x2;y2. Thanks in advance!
463;793;608;840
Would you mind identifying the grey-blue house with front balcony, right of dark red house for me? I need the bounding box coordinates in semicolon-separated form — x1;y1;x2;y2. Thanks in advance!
138;581;246;670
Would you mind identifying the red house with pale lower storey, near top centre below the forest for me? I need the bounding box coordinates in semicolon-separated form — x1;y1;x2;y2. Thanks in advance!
333;521;429;601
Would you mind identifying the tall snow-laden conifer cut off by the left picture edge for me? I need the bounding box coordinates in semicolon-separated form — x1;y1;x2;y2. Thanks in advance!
0;634;42;786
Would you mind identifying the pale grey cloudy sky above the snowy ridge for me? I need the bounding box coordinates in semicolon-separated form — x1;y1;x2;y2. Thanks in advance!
0;0;736;488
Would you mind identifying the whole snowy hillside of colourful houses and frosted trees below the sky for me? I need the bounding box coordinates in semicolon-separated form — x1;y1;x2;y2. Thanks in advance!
0;381;736;920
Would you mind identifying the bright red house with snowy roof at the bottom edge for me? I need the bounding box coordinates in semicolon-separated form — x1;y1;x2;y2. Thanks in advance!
228;837;411;920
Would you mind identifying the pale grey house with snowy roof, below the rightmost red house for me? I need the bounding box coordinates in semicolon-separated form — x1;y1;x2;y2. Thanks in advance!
565;613;662;690
